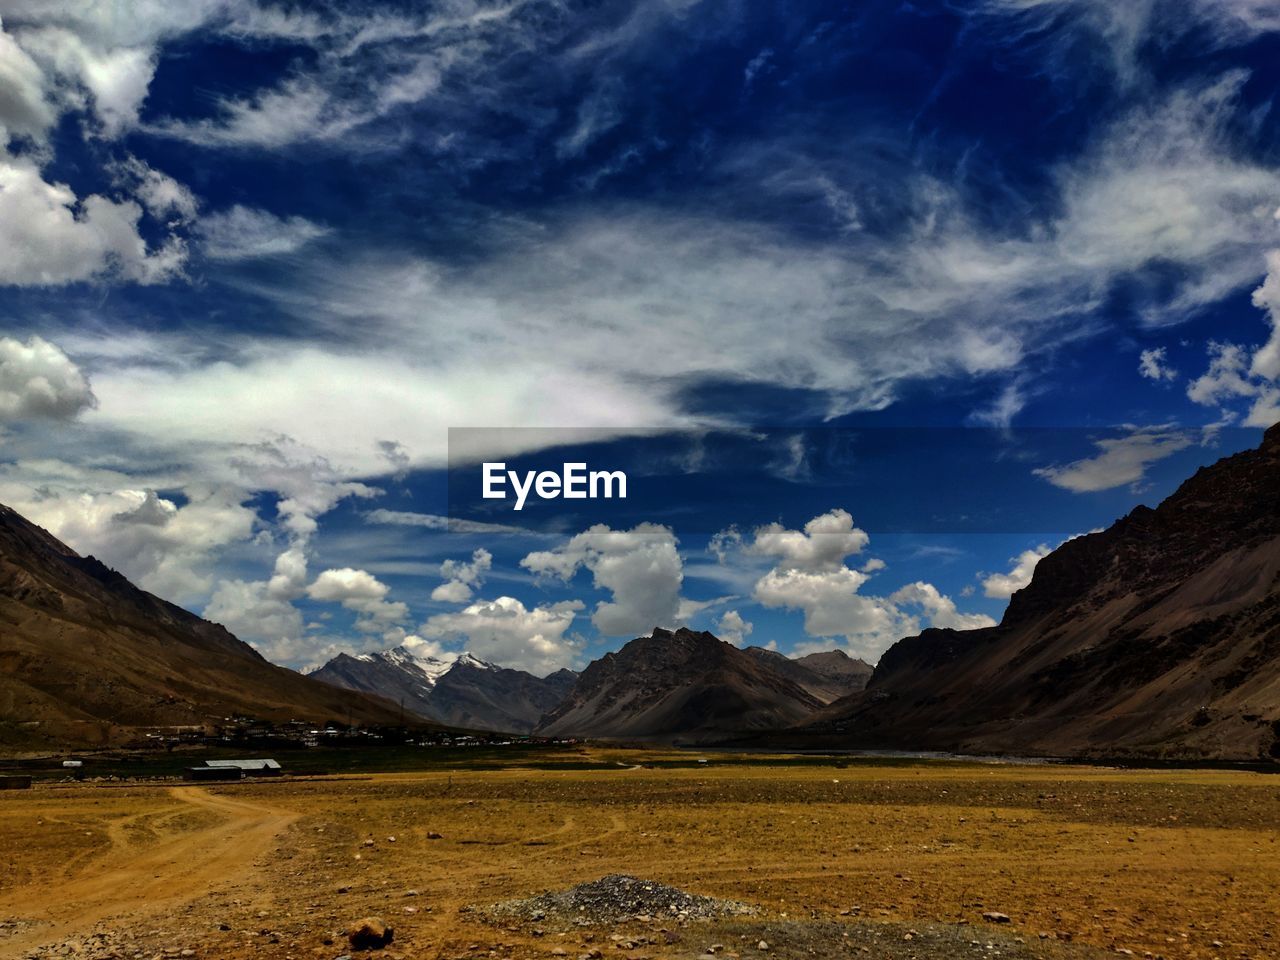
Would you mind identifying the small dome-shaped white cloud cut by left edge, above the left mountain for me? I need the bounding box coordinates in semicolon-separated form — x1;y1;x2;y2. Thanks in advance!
0;337;96;421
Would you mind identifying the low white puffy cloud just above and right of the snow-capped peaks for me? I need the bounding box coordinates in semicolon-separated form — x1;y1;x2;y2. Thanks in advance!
419;596;582;676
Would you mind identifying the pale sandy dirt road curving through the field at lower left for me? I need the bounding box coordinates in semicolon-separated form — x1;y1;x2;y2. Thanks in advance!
0;787;300;956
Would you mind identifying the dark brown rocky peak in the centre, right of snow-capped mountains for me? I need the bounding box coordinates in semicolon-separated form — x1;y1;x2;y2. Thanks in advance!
535;628;823;741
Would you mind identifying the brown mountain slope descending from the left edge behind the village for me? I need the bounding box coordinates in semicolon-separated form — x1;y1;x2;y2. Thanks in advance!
0;506;409;745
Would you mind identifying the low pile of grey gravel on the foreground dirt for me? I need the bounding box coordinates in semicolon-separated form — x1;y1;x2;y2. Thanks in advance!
485;873;756;925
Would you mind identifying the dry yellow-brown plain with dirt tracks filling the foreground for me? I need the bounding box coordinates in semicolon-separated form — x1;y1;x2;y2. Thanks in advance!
0;750;1280;960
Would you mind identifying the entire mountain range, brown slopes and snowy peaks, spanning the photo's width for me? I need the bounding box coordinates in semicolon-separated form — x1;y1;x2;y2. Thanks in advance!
0;426;1280;760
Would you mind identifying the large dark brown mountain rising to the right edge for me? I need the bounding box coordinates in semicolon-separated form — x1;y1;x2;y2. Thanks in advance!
792;425;1280;760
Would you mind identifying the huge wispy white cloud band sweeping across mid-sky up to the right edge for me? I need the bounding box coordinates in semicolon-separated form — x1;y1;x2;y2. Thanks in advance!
49;69;1280;488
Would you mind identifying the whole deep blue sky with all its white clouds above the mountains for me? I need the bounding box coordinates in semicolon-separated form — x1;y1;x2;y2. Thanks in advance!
0;0;1280;673
